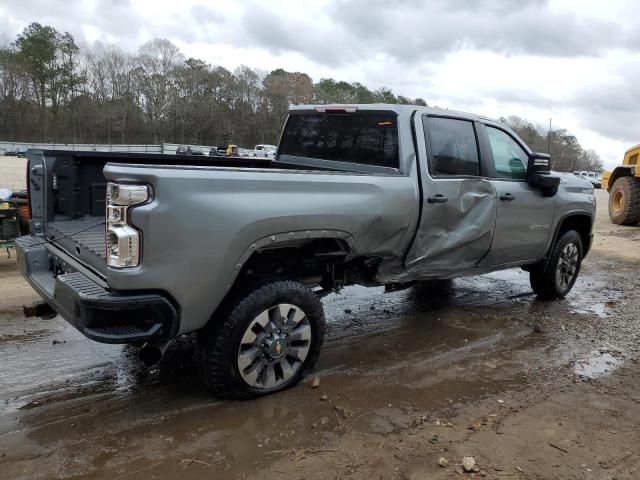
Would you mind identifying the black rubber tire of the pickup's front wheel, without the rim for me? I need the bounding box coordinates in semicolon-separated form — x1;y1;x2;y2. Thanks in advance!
529;230;583;300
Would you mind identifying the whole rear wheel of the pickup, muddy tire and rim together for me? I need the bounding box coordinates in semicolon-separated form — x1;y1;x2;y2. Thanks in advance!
198;280;325;398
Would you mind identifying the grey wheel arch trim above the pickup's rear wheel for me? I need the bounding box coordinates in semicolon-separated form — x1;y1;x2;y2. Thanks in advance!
226;229;357;291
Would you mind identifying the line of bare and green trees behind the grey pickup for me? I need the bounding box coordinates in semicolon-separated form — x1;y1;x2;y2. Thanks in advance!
0;23;599;170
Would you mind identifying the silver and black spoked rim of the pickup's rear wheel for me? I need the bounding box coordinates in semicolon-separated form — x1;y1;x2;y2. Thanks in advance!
237;303;312;390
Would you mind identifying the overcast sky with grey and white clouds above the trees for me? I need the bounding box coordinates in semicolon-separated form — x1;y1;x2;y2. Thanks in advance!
0;0;640;166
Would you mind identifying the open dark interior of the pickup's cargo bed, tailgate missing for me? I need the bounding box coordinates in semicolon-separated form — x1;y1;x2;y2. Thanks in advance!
28;150;364;277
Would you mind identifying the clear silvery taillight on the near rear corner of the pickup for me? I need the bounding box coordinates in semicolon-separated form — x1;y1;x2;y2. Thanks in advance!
106;183;151;268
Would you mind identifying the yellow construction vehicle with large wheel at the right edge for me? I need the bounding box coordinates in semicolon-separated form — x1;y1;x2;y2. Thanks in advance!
602;145;640;225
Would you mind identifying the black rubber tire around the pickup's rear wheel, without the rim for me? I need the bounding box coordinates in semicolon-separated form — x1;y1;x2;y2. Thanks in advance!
197;279;325;399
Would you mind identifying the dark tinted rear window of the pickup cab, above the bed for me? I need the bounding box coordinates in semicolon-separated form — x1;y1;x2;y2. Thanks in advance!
278;112;399;168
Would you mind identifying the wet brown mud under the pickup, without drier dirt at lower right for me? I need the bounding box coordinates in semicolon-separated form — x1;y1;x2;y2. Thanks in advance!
0;262;632;478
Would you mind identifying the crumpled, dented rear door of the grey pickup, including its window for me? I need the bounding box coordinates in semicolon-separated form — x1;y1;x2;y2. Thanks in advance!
405;115;496;278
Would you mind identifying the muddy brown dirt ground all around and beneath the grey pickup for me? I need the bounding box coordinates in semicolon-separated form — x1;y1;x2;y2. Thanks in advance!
0;182;640;480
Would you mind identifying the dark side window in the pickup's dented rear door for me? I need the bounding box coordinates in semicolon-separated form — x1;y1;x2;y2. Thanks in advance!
425;117;480;177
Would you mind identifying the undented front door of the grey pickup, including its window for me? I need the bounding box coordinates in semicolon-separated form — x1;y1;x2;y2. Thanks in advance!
479;125;555;266
